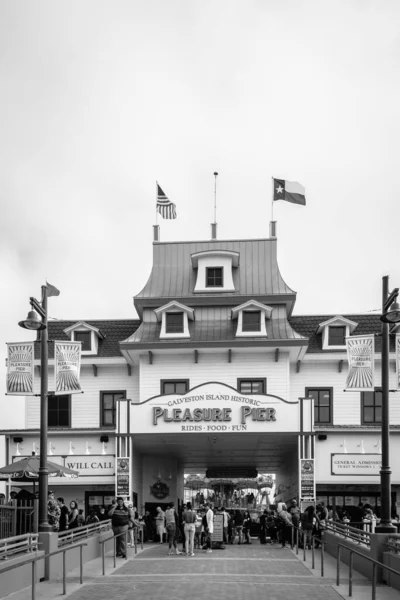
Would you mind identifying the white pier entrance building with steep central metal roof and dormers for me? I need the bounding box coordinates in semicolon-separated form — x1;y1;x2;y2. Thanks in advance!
2;227;400;513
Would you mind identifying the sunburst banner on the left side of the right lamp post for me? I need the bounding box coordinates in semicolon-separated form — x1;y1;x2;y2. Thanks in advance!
346;335;375;392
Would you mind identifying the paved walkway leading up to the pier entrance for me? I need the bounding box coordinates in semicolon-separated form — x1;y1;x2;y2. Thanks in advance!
3;541;400;600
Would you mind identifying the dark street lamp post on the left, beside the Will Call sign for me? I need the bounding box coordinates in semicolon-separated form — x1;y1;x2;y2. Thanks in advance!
19;285;53;532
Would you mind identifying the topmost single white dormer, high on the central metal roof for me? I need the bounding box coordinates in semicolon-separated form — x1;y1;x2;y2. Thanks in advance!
191;250;239;294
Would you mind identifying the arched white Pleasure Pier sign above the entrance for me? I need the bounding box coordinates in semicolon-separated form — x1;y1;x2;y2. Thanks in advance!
131;382;312;433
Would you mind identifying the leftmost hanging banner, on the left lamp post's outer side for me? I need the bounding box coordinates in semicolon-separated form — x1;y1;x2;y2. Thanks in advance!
7;342;35;396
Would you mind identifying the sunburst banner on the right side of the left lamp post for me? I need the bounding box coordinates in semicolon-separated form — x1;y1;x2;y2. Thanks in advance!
54;342;82;394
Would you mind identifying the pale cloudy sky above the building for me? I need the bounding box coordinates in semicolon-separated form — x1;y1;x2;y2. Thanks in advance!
0;0;400;427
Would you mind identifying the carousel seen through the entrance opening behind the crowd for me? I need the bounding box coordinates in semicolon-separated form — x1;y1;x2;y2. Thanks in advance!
184;474;275;512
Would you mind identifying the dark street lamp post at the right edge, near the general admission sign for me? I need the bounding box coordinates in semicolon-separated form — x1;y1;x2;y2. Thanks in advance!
375;275;400;533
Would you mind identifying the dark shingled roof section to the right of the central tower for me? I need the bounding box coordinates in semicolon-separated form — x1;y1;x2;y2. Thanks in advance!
288;314;395;353
